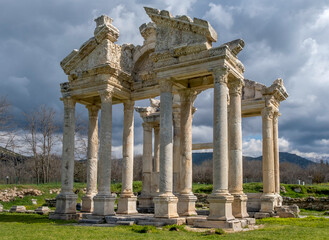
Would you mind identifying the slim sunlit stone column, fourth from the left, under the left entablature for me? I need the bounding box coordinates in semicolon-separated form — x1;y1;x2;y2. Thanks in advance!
117;100;137;214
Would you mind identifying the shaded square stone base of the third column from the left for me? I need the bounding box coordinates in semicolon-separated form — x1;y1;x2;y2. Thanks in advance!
93;194;115;216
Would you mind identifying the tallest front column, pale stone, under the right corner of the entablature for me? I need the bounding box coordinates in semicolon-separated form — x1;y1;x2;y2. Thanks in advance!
208;68;234;220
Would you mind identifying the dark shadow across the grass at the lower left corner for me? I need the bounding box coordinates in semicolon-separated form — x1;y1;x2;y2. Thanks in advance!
0;213;76;224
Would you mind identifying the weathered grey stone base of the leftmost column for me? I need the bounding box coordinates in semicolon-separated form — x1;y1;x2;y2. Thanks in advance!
55;193;78;214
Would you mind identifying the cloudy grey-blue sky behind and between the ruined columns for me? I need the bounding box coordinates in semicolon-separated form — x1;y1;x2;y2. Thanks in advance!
0;0;329;159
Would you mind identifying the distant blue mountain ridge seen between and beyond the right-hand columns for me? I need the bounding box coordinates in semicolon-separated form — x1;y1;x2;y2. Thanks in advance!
192;152;316;168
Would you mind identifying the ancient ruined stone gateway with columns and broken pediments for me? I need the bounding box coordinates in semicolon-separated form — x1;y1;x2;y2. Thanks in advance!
51;8;288;227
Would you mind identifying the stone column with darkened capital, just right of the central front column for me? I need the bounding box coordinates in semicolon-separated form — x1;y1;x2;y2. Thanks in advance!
178;89;197;216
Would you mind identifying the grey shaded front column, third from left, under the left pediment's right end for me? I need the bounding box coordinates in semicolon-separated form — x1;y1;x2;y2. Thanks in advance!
93;87;115;216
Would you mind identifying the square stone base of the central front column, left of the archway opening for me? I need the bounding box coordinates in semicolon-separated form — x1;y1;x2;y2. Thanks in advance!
153;194;178;218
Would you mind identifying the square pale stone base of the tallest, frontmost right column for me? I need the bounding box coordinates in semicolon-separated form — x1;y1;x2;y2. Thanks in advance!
207;193;235;221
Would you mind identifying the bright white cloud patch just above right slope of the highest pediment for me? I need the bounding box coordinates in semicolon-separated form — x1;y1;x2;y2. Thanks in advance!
203;3;234;29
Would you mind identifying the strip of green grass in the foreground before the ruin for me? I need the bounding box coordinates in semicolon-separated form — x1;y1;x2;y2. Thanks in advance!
0;213;329;240
